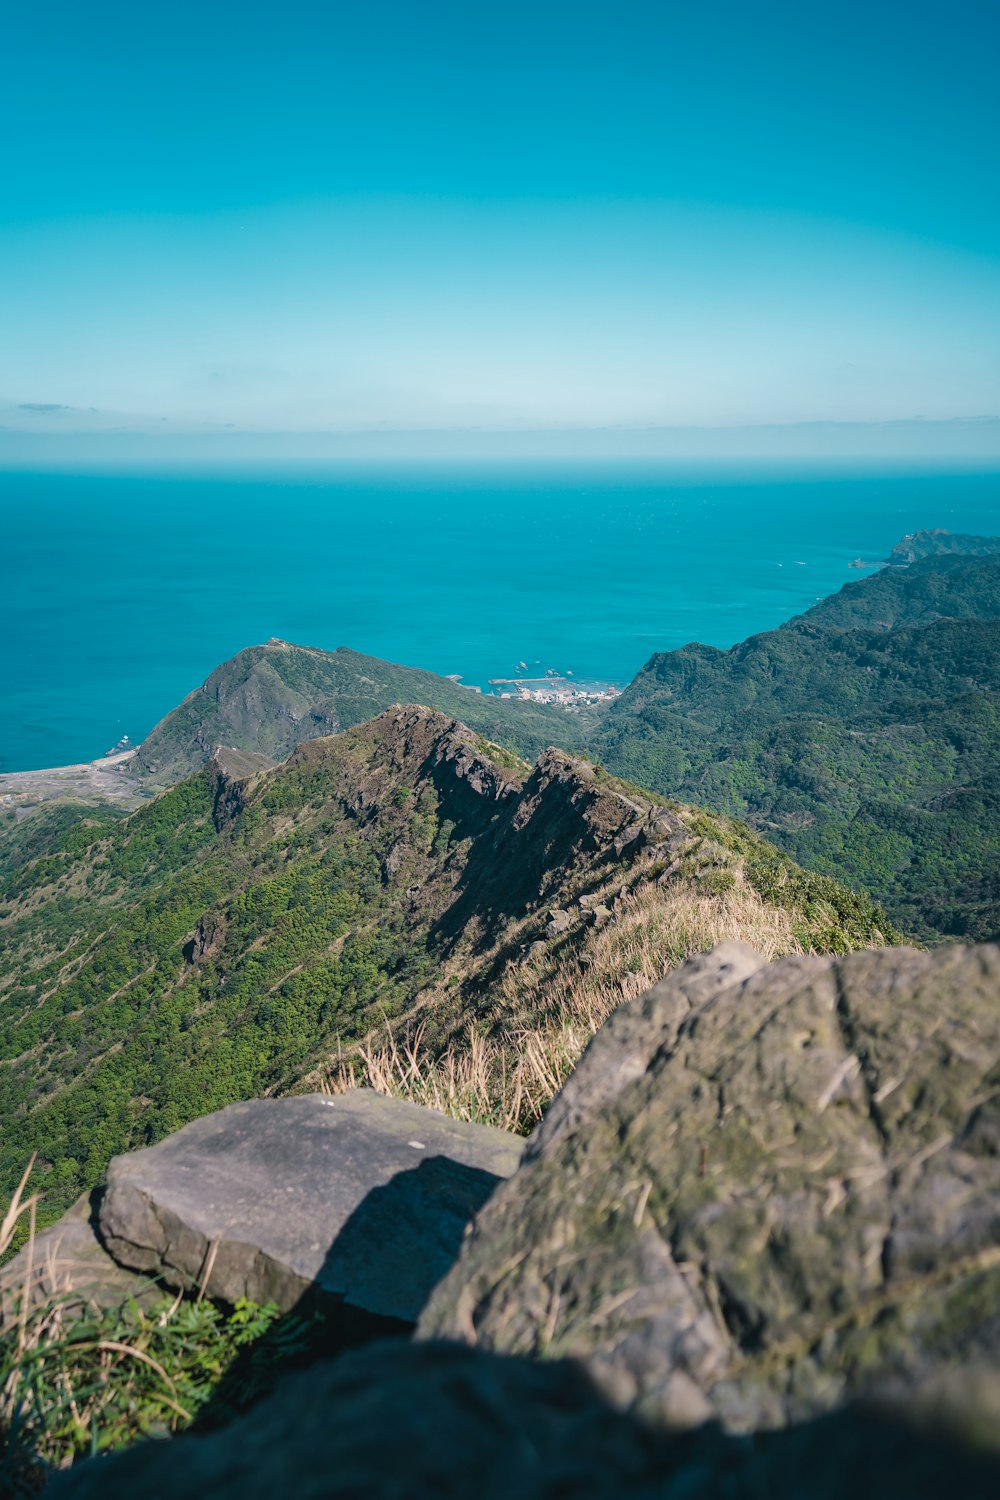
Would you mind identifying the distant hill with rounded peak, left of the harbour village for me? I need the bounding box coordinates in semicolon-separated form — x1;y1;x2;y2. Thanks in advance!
130;641;591;786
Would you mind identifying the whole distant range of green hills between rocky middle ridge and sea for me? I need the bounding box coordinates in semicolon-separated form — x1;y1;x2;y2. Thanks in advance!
0;531;1000;941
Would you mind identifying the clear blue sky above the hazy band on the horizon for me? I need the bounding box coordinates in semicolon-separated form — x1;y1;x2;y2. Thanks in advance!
0;0;1000;432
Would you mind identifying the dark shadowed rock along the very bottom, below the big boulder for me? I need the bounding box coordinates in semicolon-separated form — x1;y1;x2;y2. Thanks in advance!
46;1343;1000;1500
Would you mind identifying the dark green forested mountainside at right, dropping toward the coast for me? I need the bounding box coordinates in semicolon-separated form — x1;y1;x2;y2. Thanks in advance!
592;546;1000;939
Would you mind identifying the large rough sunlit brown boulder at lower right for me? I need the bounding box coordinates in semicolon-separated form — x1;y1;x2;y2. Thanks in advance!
420;945;1000;1430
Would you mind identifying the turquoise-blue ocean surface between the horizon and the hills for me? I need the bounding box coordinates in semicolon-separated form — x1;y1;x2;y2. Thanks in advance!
0;462;1000;771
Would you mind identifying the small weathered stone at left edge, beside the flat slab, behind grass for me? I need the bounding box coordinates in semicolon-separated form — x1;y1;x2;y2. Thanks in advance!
0;1188;163;1329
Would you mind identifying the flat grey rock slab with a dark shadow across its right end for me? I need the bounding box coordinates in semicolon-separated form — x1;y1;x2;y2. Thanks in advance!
100;1089;523;1323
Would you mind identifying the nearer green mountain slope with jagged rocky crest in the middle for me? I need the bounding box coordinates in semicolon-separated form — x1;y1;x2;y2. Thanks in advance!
0;708;894;1217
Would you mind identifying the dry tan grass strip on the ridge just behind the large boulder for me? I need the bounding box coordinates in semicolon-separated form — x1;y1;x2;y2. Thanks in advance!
325;875;802;1133
